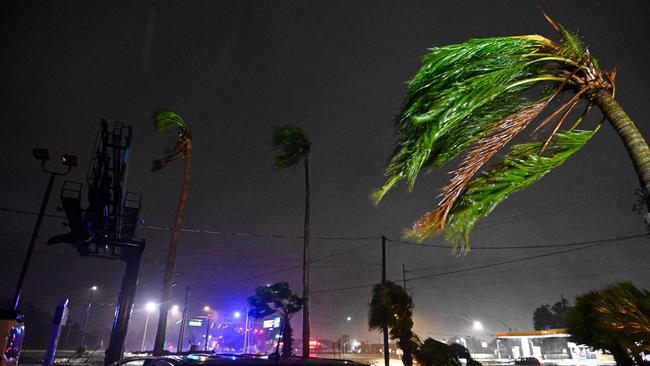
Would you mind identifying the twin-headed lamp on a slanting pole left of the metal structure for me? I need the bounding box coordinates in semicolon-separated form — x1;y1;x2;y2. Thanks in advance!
12;149;77;311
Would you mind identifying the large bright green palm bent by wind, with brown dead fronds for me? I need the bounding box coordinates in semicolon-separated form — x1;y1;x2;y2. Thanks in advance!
373;16;650;253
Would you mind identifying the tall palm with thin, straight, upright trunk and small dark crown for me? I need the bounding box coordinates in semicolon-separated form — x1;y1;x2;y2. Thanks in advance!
273;126;311;357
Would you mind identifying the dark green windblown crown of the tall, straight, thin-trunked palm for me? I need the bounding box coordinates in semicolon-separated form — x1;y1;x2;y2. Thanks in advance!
273;126;310;169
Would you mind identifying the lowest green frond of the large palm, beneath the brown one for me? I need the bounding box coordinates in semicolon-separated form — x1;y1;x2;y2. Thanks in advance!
409;129;598;253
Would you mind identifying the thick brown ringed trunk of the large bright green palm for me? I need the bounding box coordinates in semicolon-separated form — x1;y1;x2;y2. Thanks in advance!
594;90;650;211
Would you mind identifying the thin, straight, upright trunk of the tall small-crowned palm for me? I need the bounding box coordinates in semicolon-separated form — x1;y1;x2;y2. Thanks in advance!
302;148;311;357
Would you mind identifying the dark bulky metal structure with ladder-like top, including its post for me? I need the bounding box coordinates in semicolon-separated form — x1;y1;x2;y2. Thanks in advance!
48;119;145;364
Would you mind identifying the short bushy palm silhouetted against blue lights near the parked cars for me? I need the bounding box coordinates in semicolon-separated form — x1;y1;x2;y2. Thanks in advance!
248;282;304;358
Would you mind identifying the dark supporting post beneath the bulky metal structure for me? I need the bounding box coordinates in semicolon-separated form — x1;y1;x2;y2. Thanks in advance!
104;246;144;365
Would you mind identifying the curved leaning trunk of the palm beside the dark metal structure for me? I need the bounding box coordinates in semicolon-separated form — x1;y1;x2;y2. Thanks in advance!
154;139;191;355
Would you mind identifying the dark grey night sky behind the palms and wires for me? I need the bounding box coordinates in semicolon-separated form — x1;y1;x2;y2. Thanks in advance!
0;1;650;341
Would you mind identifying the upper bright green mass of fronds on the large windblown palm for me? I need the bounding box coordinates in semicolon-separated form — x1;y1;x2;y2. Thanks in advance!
373;36;561;202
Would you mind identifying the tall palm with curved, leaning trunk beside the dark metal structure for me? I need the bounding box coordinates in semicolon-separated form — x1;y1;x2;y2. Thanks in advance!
151;109;192;355
